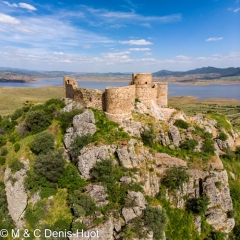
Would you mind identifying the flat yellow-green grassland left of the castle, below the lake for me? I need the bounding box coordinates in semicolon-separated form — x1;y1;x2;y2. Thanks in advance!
0;87;64;115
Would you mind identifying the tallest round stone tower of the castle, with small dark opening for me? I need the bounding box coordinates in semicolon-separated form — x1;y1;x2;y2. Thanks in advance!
131;73;156;105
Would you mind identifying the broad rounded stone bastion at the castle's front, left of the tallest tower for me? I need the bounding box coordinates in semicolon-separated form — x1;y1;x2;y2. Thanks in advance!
105;85;135;121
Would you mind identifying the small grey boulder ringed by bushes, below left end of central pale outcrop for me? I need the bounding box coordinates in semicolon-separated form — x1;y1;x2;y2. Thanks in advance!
86;184;108;207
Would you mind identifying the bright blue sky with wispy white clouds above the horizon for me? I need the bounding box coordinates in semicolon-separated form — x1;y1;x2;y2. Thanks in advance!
0;0;240;72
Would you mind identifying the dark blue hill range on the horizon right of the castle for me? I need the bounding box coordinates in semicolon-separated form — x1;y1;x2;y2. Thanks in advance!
153;67;240;77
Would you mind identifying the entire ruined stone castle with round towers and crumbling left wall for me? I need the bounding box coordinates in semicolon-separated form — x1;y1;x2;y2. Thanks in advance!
63;73;168;122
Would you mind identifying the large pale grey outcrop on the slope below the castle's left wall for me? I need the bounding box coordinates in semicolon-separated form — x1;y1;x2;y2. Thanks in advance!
64;109;96;149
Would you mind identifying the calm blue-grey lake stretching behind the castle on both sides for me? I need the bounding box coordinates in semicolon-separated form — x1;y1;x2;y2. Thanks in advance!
0;78;240;100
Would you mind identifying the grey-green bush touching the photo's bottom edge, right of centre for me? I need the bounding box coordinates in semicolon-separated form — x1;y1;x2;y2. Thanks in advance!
144;206;168;240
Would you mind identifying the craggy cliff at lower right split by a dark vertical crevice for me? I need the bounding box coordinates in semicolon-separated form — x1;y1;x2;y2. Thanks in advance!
164;169;235;233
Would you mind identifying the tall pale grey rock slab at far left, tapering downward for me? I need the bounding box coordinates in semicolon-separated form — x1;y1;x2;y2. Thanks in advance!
4;162;29;229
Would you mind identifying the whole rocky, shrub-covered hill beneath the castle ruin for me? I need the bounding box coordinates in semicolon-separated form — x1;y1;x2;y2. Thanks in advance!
0;94;240;240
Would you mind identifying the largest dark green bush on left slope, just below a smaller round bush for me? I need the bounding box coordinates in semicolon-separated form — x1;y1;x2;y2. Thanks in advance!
33;150;65;183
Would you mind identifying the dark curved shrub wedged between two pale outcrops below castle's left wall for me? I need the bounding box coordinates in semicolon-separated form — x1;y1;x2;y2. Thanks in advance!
70;134;93;163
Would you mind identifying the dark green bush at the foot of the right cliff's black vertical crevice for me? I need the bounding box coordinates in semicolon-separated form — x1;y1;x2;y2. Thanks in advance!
186;195;210;215
